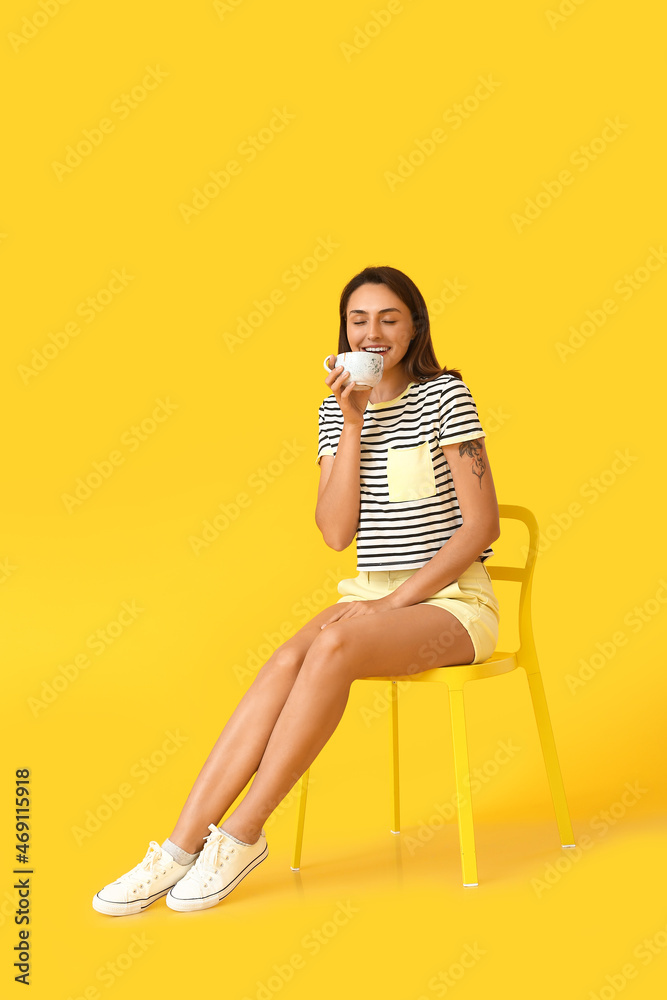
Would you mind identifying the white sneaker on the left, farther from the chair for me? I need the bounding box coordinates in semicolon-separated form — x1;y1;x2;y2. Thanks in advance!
93;840;195;917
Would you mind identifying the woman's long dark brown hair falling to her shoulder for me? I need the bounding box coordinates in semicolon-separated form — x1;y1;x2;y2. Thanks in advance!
338;267;463;382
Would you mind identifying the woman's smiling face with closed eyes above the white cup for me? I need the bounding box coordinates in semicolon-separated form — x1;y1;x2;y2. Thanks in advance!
346;284;415;372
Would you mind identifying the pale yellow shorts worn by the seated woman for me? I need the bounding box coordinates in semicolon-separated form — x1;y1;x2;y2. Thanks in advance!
336;561;500;663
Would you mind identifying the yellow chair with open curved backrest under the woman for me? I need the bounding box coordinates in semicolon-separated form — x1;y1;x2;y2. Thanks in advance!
291;504;575;886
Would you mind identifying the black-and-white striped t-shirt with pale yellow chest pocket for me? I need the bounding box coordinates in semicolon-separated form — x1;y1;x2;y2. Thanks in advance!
317;373;494;572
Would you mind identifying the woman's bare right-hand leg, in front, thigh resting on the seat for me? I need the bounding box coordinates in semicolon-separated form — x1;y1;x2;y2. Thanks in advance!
222;604;474;850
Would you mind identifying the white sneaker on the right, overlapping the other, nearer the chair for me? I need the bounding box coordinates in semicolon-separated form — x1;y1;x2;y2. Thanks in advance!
167;823;269;912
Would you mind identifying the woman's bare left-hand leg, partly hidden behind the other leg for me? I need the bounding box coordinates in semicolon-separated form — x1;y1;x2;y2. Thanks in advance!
169;605;350;854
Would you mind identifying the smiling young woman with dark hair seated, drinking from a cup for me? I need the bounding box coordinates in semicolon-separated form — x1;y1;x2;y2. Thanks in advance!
93;267;500;916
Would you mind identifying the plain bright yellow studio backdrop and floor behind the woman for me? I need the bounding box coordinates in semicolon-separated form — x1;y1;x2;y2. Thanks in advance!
0;0;667;1000
